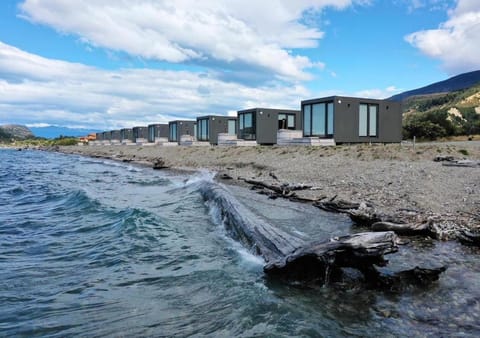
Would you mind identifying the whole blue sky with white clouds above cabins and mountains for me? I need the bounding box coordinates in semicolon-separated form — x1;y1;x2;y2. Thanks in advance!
0;0;480;130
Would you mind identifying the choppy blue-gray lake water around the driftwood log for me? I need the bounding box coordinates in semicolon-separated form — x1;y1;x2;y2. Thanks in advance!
0;149;480;337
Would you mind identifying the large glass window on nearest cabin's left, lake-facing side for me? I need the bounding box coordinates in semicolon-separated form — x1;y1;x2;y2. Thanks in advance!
303;102;334;137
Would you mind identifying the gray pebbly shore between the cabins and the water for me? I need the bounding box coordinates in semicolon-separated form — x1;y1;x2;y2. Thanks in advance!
58;141;480;239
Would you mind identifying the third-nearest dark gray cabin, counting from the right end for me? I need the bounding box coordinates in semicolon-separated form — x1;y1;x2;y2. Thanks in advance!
197;115;237;145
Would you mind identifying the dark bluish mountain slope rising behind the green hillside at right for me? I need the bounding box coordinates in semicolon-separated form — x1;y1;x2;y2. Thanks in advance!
390;70;480;101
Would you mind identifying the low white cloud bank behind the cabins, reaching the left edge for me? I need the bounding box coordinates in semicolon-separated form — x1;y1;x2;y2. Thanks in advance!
0;42;309;129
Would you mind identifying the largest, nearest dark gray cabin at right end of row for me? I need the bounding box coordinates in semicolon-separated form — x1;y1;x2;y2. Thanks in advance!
301;96;402;144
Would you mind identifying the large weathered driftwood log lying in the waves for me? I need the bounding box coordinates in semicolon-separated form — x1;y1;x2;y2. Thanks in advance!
199;182;445;289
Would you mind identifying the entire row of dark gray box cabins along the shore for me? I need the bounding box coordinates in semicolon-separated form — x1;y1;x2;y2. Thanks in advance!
94;96;402;146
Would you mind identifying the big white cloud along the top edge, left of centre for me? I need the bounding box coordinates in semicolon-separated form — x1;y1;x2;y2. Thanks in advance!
20;0;369;81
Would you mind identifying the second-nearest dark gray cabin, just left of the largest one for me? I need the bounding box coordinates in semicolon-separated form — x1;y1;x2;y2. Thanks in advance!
237;108;302;144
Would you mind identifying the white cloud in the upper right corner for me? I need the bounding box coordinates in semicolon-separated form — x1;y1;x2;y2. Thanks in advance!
405;0;480;74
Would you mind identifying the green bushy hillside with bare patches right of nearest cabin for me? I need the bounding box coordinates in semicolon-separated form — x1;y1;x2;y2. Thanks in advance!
403;84;480;140
